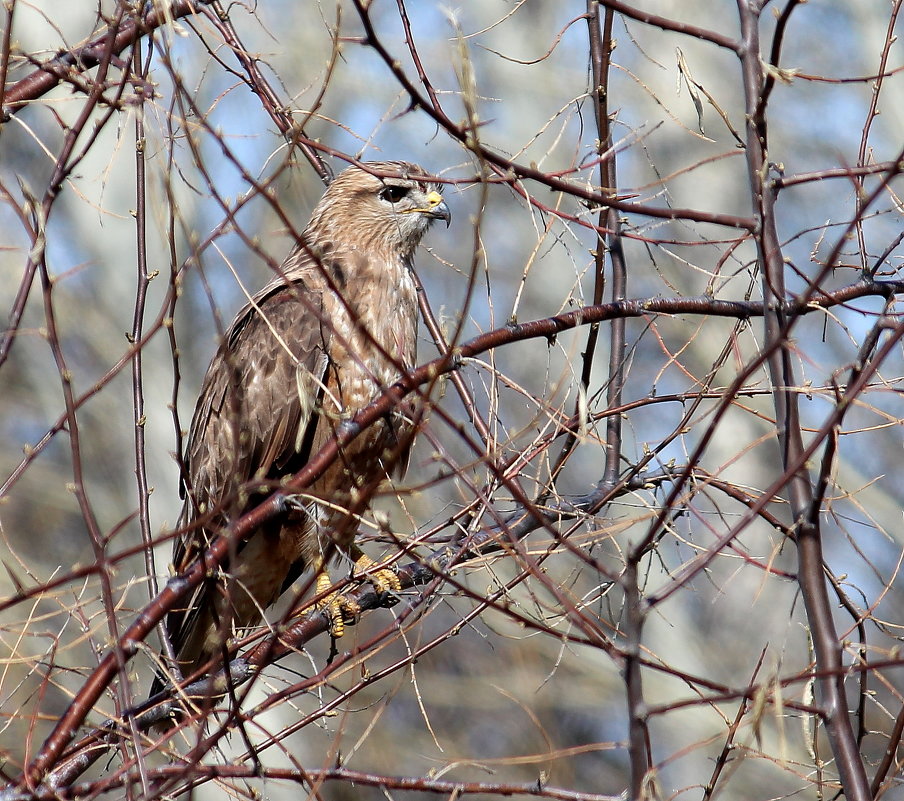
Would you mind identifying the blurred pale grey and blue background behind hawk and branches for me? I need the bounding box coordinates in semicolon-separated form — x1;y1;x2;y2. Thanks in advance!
0;0;904;799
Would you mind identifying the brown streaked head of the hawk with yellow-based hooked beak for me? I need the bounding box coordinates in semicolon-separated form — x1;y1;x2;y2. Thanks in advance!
308;161;452;260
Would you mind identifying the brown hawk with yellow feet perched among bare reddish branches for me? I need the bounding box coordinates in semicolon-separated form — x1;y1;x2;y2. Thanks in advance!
158;161;451;686
